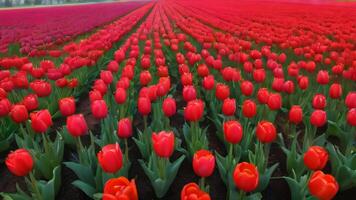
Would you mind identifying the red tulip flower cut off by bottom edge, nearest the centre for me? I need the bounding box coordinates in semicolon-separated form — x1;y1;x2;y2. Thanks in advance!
180;183;211;200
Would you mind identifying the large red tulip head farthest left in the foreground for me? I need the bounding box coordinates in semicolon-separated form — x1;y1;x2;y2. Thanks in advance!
5;149;33;176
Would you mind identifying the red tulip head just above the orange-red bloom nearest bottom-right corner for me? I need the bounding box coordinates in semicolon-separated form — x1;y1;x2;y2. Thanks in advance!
303;146;329;170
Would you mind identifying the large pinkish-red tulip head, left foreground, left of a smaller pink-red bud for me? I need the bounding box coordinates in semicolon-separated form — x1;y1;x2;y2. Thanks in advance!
67;114;88;137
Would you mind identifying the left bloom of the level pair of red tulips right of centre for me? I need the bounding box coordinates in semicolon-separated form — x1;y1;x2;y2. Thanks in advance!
223;120;243;144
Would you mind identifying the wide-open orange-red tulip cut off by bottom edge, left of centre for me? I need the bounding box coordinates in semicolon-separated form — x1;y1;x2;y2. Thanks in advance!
103;176;138;200
